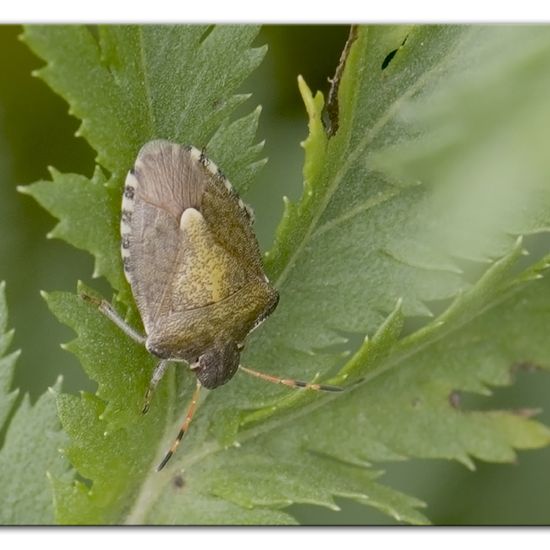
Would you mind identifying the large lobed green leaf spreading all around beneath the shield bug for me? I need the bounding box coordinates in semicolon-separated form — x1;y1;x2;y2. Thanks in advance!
18;26;550;524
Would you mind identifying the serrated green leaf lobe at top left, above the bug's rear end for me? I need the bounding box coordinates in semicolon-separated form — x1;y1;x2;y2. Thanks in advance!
24;25;265;176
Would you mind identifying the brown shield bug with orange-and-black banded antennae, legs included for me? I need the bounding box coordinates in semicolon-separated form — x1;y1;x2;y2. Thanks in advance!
85;140;342;470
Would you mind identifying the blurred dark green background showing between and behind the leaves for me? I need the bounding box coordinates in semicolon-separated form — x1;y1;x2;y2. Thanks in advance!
0;25;550;524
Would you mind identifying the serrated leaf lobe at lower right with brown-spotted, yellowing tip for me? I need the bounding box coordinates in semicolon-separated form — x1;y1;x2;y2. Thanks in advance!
303;280;550;467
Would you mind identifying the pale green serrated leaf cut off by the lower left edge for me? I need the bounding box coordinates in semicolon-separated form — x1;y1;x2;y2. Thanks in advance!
0;282;67;525
